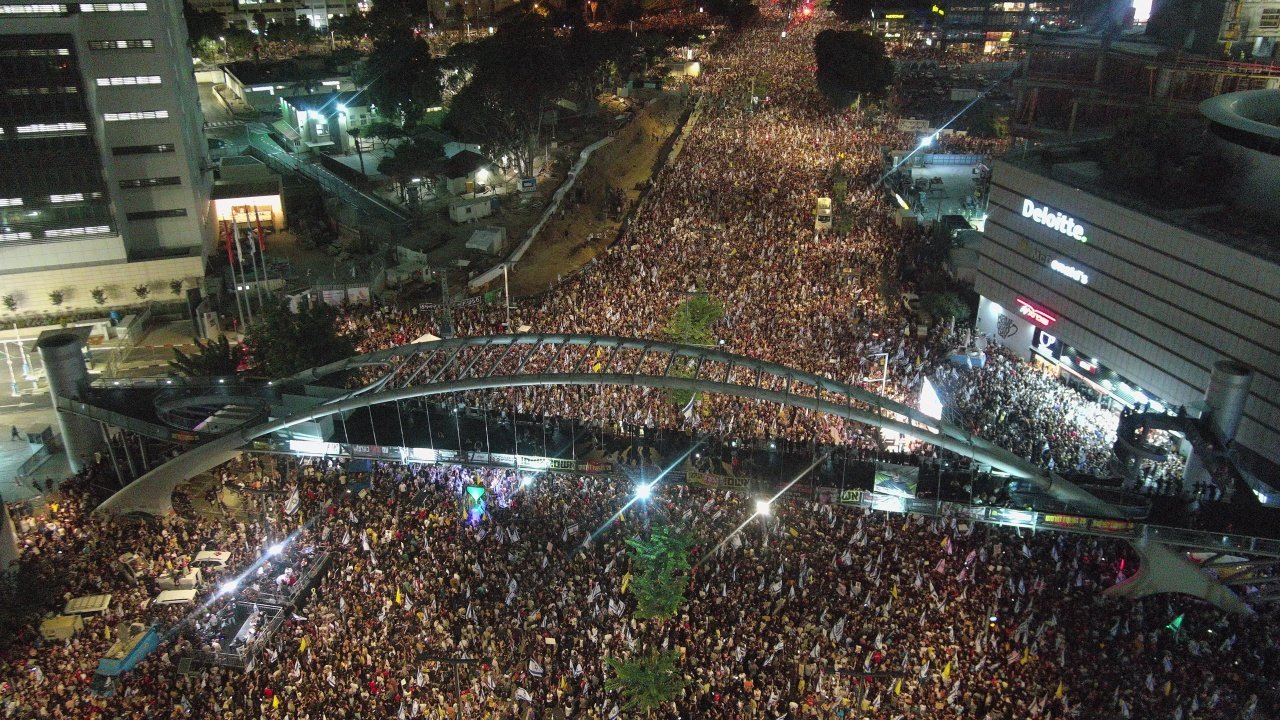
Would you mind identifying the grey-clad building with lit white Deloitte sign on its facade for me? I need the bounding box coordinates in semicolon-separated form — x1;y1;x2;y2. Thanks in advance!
975;101;1280;479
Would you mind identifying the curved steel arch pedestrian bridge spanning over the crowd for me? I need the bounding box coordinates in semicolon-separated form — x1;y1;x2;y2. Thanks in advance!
59;333;1245;611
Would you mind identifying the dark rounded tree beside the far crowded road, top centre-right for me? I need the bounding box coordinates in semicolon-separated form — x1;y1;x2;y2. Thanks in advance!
814;29;893;108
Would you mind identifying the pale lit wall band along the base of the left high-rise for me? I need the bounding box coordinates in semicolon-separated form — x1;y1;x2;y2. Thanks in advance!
0;258;205;315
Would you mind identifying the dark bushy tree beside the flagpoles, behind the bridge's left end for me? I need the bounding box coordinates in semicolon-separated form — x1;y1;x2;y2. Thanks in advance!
244;297;356;378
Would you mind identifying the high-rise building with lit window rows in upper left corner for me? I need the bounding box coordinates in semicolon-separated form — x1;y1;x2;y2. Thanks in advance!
0;0;214;313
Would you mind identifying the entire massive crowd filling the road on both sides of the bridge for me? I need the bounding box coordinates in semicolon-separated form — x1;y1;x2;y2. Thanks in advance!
0;5;1259;720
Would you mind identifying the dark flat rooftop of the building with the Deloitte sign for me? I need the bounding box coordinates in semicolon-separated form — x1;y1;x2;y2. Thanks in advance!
1001;140;1280;265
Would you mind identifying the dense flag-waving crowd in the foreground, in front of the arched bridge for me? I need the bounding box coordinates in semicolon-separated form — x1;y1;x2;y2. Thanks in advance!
0;456;1280;720
